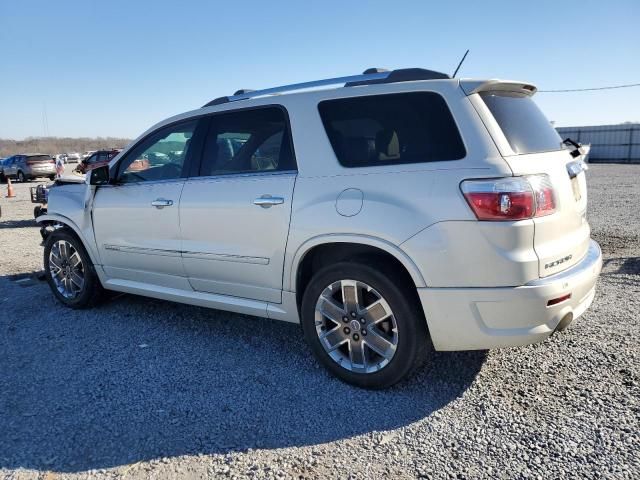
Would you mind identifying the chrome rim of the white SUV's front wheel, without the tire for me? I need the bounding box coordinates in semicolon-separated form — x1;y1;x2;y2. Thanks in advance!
49;240;84;299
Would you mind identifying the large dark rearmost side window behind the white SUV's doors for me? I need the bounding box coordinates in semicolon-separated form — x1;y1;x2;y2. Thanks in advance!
318;92;466;168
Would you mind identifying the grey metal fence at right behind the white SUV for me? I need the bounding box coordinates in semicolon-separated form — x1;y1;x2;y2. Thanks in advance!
557;123;640;163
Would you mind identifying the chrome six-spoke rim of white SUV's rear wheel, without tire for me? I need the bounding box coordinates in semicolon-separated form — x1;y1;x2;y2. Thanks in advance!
315;280;398;373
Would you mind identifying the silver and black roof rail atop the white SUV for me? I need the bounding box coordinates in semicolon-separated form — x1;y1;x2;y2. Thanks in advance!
202;68;450;108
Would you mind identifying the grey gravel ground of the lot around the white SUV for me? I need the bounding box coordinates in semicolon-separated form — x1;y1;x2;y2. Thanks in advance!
0;165;640;479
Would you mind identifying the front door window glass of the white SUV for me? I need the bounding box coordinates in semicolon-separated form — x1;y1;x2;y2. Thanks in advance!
118;120;198;183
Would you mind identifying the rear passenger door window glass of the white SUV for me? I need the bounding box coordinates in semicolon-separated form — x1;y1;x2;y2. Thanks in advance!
201;107;296;176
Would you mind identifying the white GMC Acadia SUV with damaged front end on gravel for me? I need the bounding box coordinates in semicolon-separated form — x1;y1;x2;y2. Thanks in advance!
38;69;602;388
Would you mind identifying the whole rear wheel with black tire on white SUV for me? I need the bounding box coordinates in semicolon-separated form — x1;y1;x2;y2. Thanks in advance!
302;262;432;388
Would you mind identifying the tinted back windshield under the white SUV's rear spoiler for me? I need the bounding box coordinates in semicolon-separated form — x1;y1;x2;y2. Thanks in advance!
480;92;562;153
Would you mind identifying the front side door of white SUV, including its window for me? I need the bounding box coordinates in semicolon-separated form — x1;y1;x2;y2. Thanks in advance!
93;120;197;291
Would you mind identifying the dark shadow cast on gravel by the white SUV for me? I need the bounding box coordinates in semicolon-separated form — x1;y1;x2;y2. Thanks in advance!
0;277;485;472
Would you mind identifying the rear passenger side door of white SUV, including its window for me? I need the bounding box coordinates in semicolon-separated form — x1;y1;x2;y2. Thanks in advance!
180;107;297;303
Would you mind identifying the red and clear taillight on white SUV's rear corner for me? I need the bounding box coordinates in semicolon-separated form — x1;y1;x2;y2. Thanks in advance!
460;175;556;221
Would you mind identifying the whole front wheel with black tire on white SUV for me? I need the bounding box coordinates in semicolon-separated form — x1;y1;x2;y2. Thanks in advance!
44;229;103;308
